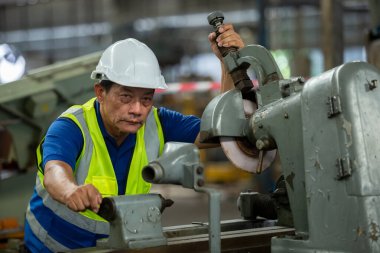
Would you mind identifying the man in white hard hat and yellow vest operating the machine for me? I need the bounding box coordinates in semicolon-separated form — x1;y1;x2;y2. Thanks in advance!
25;25;244;252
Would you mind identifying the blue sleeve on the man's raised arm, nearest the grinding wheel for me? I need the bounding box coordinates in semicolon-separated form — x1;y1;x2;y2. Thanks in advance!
158;107;201;143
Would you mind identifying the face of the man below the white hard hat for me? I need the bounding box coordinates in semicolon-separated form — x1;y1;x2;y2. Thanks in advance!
95;84;154;138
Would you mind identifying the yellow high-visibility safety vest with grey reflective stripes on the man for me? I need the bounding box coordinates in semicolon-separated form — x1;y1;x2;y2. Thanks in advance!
26;98;164;252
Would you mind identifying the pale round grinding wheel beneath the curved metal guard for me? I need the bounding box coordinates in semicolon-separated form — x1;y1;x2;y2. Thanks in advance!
220;100;276;173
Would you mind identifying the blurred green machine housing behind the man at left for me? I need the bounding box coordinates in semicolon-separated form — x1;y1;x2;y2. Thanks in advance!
0;52;101;170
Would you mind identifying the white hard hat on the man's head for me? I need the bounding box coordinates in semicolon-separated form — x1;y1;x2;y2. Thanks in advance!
91;38;167;89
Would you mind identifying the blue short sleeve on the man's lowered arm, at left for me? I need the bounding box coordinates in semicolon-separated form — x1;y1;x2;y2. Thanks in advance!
42;118;83;170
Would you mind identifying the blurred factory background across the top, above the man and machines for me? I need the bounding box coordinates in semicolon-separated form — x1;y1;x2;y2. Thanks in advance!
0;0;378;83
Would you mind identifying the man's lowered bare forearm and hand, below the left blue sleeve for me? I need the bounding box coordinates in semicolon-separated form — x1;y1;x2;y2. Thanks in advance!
44;160;102;212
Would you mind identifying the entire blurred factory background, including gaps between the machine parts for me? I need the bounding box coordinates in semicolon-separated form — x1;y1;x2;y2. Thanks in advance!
0;0;380;251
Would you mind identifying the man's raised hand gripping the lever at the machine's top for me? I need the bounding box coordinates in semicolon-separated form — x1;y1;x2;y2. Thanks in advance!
208;24;244;60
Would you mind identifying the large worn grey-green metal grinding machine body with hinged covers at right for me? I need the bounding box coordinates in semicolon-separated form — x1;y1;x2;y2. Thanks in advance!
201;40;380;252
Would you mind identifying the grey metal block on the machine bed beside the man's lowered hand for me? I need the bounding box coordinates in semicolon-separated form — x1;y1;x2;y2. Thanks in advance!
97;194;168;249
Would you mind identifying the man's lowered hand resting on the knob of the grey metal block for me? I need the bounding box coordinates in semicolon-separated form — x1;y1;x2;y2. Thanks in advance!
63;184;102;213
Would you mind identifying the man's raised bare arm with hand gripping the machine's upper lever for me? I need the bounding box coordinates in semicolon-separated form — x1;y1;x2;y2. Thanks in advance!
194;24;244;149
